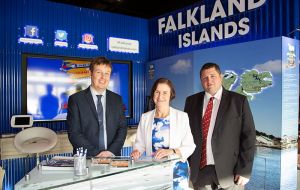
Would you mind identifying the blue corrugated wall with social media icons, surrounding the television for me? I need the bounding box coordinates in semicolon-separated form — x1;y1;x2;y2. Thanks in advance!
0;0;149;134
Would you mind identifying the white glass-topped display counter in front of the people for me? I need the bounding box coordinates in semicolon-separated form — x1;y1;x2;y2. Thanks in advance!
15;157;178;190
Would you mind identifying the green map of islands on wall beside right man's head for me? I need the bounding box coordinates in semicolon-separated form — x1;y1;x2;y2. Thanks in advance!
223;69;273;100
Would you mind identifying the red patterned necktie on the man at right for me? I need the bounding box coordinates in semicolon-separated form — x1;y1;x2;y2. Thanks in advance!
200;97;214;169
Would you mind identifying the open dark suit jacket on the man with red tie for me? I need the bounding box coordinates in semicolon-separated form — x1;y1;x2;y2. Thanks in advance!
184;88;256;188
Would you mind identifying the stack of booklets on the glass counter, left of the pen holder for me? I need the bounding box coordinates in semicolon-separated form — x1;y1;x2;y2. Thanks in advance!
41;156;74;170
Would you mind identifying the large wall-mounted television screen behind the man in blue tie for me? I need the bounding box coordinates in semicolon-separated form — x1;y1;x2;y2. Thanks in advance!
22;54;132;121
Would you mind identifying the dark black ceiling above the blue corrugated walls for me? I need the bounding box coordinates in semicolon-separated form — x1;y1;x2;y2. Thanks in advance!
49;0;200;19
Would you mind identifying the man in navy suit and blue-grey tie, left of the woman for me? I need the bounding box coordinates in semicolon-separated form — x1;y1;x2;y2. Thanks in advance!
67;57;127;157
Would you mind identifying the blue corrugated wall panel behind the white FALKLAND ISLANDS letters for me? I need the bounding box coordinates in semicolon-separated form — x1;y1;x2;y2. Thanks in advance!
149;0;300;60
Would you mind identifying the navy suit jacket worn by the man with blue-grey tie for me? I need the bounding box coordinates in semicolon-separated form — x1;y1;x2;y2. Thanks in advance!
67;88;127;156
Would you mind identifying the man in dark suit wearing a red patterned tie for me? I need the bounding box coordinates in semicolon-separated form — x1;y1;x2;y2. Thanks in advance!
184;63;256;190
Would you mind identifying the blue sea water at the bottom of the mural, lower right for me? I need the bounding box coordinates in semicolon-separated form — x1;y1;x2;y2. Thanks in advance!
245;147;297;190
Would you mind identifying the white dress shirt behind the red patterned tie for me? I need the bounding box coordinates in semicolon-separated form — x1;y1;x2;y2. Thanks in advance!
202;87;223;165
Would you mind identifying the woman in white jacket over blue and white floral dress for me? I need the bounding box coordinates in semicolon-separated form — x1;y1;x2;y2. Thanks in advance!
131;78;195;189
